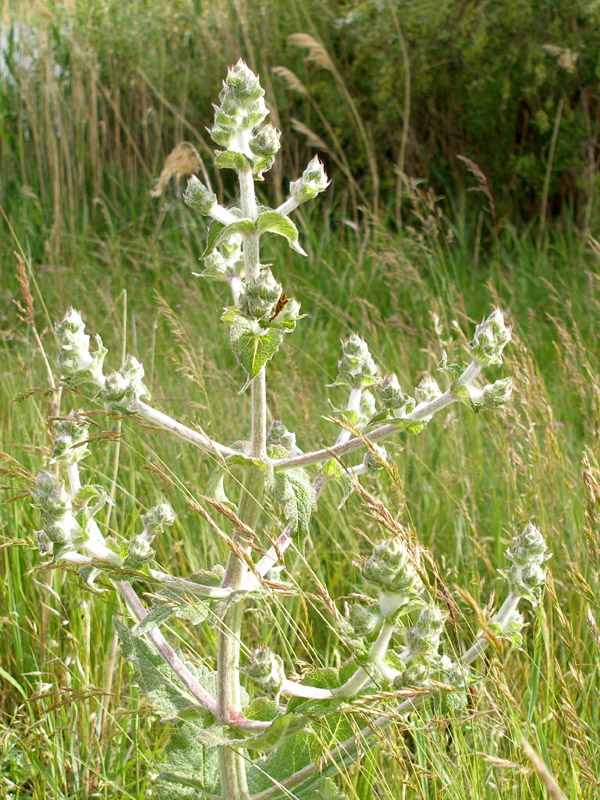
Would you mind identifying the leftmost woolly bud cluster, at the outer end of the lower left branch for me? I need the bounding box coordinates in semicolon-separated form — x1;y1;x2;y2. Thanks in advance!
31;471;82;556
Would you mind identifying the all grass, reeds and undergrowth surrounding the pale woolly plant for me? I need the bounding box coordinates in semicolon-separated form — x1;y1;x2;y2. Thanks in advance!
0;0;600;800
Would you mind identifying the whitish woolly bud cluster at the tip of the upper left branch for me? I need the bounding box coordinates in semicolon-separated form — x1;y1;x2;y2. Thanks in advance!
55;308;107;386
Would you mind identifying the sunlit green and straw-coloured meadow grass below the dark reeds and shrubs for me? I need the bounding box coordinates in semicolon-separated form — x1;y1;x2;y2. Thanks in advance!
0;207;599;800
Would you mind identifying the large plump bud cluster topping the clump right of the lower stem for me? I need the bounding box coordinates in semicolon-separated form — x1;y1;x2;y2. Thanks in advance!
361;539;425;616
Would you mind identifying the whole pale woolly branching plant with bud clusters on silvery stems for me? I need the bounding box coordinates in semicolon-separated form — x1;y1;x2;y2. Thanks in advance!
32;61;549;800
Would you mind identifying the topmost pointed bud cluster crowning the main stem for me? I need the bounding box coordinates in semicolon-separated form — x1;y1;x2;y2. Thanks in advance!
209;59;269;152
